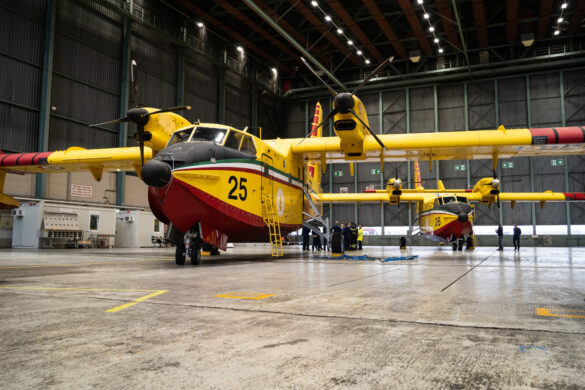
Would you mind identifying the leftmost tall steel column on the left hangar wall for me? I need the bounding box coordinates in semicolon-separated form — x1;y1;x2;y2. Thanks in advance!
36;0;56;198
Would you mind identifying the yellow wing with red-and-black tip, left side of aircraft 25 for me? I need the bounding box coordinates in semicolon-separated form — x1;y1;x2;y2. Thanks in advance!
0;147;153;181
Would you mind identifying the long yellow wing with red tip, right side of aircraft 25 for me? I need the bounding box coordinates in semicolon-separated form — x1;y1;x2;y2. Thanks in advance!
290;127;585;163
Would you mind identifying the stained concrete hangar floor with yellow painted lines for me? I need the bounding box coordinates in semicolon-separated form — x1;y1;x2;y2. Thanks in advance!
0;245;585;389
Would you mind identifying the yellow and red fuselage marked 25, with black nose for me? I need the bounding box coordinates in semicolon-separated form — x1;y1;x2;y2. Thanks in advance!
142;124;304;244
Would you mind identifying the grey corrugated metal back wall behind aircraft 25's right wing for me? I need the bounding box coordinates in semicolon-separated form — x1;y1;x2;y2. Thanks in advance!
287;70;585;232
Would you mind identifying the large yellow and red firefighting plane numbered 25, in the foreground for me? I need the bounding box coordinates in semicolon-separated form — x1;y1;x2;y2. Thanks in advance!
0;61;585;264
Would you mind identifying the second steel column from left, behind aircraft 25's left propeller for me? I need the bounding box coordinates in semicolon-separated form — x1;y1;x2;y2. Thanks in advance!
116;17;131;206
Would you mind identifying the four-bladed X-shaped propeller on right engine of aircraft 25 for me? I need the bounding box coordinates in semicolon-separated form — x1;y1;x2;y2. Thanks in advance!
299;57;394;150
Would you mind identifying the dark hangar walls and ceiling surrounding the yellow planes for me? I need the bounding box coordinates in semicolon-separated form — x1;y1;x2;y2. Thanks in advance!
0;0;585;244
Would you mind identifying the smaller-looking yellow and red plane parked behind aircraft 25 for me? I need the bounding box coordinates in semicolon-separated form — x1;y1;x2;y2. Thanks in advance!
318;162;585;250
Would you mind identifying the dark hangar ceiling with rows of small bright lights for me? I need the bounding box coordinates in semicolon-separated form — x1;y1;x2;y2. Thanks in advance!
163;0;585;87
